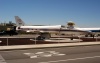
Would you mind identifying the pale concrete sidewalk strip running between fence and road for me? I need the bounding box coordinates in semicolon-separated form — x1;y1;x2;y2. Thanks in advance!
0;41;100;51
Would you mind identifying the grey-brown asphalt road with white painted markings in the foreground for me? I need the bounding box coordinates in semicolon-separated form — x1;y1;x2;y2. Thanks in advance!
0;45;100;63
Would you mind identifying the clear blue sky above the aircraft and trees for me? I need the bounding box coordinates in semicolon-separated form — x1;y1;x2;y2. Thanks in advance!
0;0;100;27
